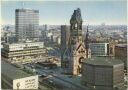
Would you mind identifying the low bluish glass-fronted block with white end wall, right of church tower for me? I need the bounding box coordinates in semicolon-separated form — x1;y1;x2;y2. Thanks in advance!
89;43;109;56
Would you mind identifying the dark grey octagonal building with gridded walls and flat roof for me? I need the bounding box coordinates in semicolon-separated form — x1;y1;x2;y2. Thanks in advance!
81;57;126;90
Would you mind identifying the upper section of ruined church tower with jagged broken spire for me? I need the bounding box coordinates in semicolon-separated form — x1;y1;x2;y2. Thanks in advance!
70;8;82;44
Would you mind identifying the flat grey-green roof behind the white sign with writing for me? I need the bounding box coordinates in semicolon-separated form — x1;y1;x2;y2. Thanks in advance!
1;60;32;80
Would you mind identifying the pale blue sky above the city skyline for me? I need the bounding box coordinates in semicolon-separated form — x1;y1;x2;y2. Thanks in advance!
1;0;127;25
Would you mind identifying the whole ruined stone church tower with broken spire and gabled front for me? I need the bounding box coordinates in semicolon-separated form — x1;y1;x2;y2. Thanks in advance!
62;8;91;75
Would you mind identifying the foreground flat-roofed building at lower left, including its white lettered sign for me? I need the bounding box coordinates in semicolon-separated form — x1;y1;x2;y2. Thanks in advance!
1;60;38;90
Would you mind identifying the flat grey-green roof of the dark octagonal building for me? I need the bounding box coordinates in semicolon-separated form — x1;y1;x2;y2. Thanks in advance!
84;57;123;66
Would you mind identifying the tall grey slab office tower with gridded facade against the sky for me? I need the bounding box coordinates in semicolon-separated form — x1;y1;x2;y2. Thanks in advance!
15;9;39;42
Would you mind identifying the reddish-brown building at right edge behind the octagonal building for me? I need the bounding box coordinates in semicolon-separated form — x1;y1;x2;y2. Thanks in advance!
115;44;128;70
